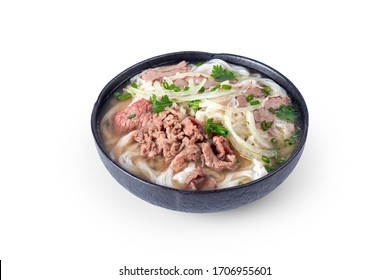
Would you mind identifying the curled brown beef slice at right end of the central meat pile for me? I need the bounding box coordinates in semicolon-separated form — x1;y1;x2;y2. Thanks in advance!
202;136;237;171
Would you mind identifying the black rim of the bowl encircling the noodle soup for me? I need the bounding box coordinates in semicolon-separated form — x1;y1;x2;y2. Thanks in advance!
91;51;309;192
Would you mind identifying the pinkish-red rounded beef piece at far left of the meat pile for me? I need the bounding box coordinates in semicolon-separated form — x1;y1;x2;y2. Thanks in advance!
113;99;153;133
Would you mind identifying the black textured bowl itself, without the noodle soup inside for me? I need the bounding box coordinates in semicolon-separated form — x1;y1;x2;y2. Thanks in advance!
91;51;309;213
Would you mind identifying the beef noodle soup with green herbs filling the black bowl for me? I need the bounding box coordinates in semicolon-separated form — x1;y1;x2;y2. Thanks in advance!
100;59;299;190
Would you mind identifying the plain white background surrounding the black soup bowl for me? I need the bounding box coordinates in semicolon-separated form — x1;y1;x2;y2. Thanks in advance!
0;0;390;280
